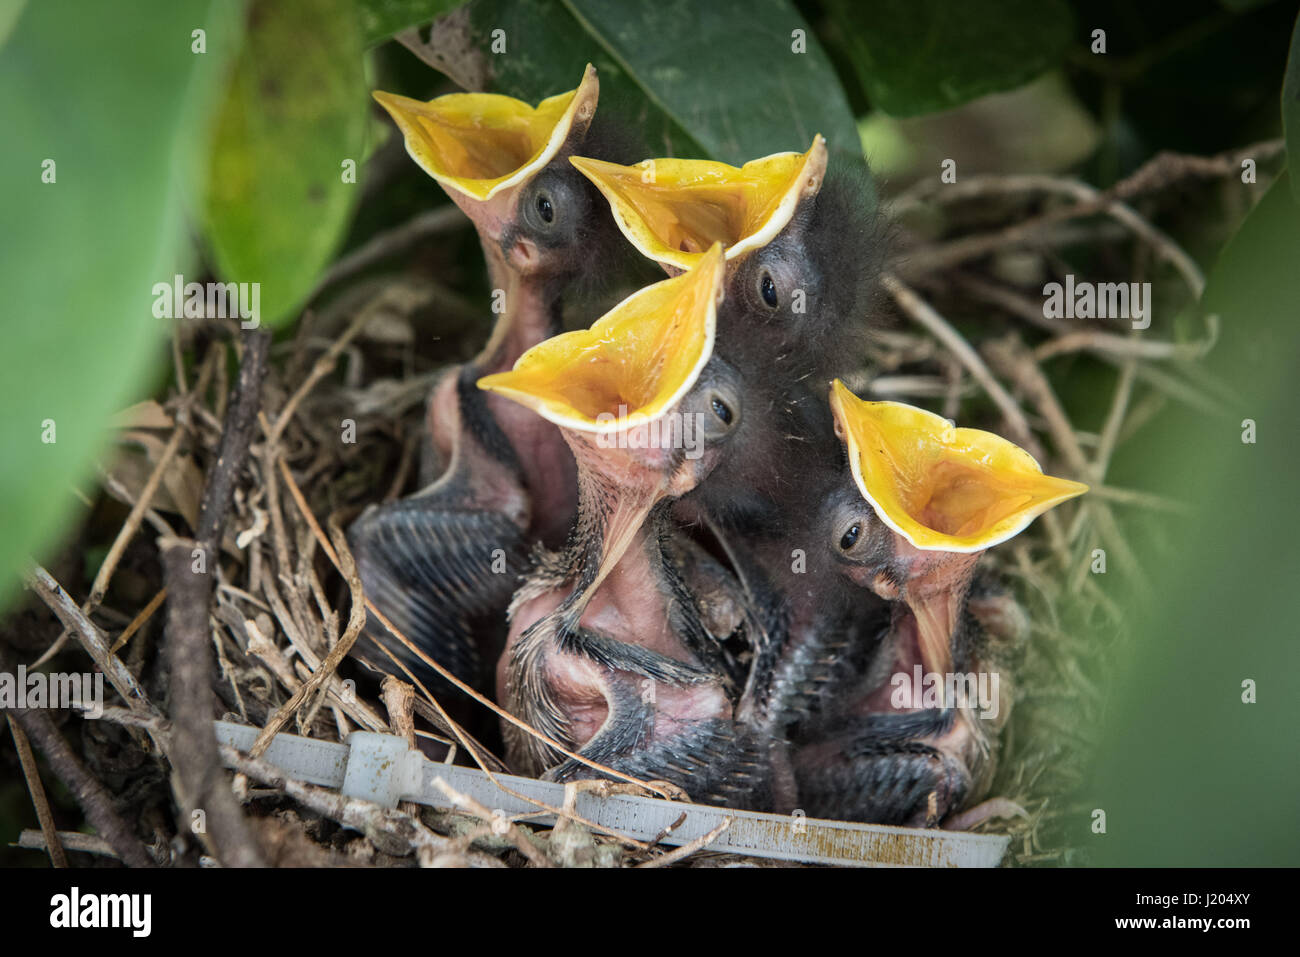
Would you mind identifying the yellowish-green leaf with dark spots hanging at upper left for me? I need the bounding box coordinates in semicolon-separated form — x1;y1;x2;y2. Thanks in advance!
205;0;368;325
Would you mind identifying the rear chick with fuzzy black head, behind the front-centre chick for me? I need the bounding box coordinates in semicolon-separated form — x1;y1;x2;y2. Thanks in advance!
572;137;884;791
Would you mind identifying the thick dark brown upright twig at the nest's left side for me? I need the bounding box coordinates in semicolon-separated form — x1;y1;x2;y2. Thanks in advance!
160;330;270;867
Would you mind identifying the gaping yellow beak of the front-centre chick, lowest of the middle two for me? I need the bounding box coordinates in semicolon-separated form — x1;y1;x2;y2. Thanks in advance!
478;243;724;433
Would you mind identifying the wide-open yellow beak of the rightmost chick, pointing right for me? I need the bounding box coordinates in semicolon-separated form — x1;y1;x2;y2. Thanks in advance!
831;380;1088;553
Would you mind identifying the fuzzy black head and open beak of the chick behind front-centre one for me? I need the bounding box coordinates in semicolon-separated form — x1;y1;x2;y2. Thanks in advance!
573;137;884;381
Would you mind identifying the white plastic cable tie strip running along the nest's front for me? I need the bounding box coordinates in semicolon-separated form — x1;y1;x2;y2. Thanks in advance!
216;722;1010;867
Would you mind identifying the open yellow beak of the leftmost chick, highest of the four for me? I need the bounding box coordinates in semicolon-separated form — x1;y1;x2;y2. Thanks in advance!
374;64;601;200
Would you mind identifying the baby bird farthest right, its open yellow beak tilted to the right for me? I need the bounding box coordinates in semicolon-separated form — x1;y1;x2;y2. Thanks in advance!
794;380;1087;827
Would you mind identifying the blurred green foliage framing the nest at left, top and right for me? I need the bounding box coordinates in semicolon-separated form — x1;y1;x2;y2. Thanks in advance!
0;0;1300;865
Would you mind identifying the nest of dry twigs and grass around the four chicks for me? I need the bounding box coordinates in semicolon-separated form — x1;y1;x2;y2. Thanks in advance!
0;143;1281;866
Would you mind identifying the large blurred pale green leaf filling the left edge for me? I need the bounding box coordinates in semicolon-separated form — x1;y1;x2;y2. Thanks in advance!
0;0;239;605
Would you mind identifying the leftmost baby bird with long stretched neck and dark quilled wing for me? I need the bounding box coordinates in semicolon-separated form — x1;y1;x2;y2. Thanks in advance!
350;66;642;700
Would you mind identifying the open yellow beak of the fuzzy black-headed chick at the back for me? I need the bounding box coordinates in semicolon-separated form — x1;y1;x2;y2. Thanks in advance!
569;134;826;269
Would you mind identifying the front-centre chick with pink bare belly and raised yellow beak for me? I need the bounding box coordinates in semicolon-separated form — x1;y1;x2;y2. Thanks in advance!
480;244;755;805
